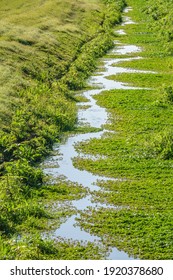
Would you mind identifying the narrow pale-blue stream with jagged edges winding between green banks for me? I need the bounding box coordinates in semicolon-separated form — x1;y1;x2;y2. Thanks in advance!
44;9;153;260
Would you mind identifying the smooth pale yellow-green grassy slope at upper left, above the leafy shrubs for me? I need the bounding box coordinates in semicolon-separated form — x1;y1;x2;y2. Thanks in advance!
0;0;102;124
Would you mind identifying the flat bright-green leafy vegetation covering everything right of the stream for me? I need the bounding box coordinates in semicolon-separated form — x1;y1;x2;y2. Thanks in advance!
74;0;173;259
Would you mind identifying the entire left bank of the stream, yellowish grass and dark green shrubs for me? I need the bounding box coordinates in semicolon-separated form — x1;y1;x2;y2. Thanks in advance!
0;0;124;259
